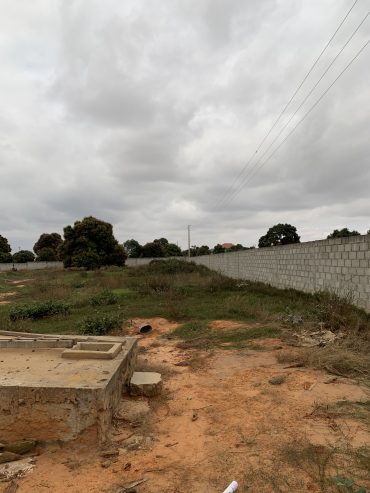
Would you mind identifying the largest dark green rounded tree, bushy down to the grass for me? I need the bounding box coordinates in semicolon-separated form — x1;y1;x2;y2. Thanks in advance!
60;216;126;269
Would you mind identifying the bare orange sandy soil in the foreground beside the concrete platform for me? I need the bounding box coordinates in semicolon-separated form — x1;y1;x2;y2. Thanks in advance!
10;319;370;493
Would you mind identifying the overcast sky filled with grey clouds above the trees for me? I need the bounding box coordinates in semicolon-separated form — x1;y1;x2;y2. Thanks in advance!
0;0;370;251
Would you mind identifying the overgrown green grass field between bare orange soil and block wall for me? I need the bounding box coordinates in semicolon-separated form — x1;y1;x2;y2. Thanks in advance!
0;259;370;378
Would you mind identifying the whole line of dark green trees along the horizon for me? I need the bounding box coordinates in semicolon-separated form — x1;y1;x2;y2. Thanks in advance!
0;216;370;269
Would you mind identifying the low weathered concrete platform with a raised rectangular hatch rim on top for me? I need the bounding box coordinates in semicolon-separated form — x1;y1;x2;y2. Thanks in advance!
0;332;137;442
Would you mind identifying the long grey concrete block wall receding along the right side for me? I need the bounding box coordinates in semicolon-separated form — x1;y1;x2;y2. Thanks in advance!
126;235;370;312
